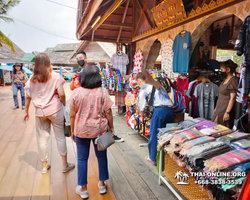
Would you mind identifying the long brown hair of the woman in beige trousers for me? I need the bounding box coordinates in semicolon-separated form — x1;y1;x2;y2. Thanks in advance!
30;53;52;83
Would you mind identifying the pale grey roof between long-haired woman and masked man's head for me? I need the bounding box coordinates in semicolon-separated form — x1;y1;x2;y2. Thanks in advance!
44;43;81;65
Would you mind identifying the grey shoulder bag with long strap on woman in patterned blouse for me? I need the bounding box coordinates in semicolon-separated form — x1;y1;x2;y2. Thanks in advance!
95;87;115;151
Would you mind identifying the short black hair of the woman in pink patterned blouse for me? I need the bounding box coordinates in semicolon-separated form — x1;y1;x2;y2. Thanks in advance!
79;65;102;89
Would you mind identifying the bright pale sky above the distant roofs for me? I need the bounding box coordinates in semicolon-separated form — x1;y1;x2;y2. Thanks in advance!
0;0;79;53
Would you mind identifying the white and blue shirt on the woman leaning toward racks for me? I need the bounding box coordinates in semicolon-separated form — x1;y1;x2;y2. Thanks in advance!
138;84;173;111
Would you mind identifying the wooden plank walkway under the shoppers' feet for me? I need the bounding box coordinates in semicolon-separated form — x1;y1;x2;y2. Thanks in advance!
0;84;176;200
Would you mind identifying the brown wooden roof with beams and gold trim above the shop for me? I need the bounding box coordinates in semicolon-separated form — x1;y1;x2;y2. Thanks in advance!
77;0;243;43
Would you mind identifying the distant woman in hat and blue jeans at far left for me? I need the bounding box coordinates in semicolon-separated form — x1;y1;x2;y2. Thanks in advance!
13;63;28;110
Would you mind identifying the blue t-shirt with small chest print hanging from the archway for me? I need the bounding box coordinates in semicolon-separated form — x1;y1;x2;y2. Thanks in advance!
173;31;191;73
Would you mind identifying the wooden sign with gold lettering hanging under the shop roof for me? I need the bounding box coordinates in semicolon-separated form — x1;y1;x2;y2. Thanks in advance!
151;0;186;27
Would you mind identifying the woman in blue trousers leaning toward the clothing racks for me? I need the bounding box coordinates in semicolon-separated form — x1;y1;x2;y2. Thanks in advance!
136;69;174;165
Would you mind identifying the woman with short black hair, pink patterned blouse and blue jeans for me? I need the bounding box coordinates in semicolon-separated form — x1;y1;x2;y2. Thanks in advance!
69;66;114;199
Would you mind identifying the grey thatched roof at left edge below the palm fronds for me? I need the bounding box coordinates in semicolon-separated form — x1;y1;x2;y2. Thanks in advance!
0;36;25;63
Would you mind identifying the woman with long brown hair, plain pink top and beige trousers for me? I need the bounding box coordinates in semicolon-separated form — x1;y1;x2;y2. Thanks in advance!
24;53;75;174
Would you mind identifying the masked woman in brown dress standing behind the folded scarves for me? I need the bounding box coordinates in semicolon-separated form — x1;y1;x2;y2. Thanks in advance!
212;60;239;128
